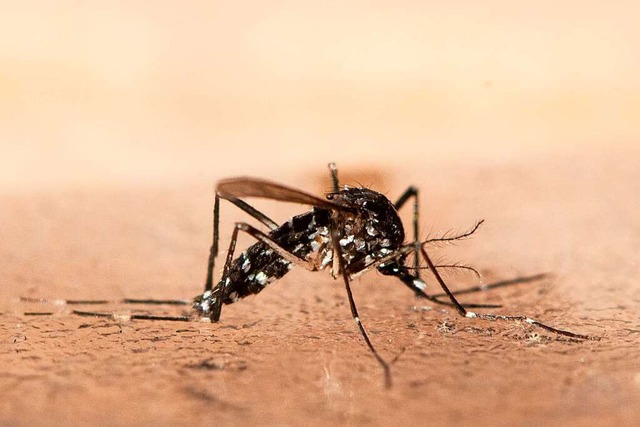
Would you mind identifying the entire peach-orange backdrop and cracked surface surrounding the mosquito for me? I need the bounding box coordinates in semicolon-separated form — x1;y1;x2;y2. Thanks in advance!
0;0;640;426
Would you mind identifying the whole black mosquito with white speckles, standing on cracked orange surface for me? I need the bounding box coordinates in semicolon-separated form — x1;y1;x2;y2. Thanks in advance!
23;163;592;387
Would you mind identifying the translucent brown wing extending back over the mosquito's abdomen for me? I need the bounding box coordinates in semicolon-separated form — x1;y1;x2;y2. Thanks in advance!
216;177;354;212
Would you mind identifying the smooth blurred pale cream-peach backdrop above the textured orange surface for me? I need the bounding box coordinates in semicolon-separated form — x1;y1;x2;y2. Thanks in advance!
0;0;640;193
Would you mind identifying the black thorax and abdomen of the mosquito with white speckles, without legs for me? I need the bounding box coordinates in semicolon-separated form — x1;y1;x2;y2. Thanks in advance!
195;186;404;320
